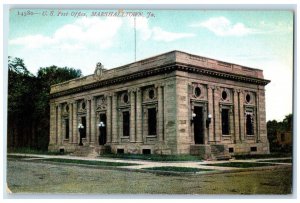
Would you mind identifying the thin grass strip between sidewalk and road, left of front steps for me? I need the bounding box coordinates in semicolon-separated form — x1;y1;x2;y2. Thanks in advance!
43;158;138;166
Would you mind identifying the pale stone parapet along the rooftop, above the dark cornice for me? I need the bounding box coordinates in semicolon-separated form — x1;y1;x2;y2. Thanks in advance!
50;50;264;94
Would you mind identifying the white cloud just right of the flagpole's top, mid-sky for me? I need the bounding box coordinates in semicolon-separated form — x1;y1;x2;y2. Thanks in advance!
130;18;195;42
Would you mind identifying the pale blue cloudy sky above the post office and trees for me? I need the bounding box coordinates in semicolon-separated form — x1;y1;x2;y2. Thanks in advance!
8;9;294;121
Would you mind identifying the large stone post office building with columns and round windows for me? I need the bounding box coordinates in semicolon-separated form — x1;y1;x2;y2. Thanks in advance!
49;51;270;159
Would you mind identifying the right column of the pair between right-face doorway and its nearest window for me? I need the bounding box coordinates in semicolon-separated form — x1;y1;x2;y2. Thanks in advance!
214;87;222;143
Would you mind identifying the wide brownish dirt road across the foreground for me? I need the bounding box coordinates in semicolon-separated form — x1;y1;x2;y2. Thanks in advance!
7;159;292;194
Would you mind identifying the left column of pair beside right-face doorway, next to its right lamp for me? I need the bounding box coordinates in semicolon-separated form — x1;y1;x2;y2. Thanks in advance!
205;85;215;144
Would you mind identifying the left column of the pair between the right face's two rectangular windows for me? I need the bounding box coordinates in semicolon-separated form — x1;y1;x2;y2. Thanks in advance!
232;89;240;143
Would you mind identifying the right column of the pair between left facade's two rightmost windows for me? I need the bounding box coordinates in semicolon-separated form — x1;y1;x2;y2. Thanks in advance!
136;88;143;143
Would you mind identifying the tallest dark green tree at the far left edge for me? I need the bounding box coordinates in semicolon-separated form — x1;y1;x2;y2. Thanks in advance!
8;57;36;147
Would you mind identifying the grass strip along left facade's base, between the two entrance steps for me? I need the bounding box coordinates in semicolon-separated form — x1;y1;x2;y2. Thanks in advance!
101;154;201;161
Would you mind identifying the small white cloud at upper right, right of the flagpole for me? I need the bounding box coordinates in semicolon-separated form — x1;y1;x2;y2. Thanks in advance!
190;16;258;36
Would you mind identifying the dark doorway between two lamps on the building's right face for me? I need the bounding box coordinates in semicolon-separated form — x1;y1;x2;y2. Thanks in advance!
194;106;204;144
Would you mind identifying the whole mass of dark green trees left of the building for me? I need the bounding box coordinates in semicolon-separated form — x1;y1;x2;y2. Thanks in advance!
8;57;81;150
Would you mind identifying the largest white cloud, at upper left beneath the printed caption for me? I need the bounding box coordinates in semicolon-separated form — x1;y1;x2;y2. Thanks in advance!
9;17;122;50
